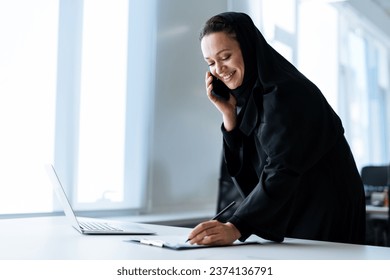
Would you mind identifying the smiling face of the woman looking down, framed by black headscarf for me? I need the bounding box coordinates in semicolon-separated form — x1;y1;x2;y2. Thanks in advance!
201;32;244;89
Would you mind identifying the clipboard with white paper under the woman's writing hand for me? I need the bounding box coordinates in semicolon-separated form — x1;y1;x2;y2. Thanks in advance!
125;235;261;250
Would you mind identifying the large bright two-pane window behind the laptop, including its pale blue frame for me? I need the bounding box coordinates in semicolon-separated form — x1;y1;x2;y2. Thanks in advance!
0;0;151;215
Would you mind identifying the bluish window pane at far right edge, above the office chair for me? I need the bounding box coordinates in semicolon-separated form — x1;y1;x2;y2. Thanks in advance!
340;25;390;168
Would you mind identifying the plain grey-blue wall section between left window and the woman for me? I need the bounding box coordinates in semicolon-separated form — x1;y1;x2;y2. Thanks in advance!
148;0;227;212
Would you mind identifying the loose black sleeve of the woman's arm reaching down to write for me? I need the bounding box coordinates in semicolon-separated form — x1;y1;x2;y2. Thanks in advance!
229;83;343;242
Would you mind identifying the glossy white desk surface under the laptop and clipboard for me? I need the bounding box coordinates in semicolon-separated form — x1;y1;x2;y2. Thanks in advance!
0;217;390;260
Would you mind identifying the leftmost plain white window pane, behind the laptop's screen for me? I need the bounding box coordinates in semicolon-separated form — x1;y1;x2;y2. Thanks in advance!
0;0;59;214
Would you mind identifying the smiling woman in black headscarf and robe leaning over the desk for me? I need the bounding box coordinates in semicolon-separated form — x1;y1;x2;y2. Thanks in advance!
188;12;365;245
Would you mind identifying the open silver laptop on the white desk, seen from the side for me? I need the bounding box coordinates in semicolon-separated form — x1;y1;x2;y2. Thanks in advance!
46;164;155;235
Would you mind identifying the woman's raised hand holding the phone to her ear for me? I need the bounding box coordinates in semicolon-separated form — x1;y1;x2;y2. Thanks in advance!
205;72;237;131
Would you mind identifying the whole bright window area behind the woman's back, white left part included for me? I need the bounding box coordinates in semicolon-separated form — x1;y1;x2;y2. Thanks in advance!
298;1;390;169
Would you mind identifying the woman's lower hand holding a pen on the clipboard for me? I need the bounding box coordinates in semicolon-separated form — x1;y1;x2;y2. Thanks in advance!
188;220;241;245
